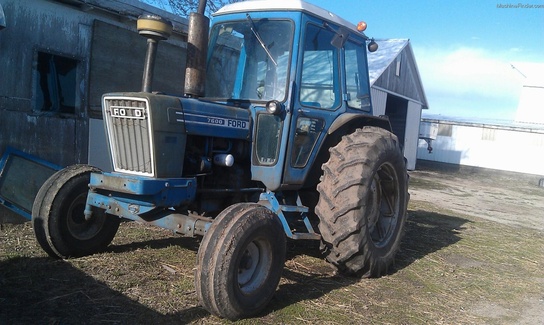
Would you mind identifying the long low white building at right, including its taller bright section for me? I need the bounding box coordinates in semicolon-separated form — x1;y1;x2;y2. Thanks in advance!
417;65;544;175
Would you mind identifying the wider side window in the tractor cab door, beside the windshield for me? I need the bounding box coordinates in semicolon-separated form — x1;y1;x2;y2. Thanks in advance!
299;25;341;109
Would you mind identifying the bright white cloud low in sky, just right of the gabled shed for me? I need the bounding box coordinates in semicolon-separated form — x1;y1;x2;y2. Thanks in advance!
414;47;524;117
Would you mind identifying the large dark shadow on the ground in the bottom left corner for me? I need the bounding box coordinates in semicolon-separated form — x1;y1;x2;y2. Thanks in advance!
0;257;203;324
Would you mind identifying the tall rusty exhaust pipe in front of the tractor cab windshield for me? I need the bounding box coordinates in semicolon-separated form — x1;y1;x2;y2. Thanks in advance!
184;0;210;98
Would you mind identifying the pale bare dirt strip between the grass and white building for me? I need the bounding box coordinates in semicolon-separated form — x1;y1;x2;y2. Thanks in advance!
410;161;544;230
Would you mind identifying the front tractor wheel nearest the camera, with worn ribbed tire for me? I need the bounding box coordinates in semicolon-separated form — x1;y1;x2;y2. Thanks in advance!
195;203;286;320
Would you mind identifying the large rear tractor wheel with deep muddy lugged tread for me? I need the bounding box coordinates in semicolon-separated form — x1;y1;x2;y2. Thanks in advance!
316;127;408;277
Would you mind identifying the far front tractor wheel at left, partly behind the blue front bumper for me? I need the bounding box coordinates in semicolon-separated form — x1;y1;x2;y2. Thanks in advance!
32;165;120;258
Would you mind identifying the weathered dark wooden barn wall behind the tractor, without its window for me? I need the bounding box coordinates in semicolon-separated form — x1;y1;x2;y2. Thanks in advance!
0;0;185;166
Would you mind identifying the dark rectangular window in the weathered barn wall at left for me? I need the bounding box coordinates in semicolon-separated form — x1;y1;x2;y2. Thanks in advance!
35;52;78;114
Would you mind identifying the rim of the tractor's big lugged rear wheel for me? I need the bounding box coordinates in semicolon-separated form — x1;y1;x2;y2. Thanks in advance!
368;163;400;247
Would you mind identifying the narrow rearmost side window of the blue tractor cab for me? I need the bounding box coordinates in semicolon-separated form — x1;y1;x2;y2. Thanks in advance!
344;41;370;111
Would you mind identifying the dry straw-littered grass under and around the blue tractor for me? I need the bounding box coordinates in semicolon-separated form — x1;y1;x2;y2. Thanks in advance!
0;166;544;324
